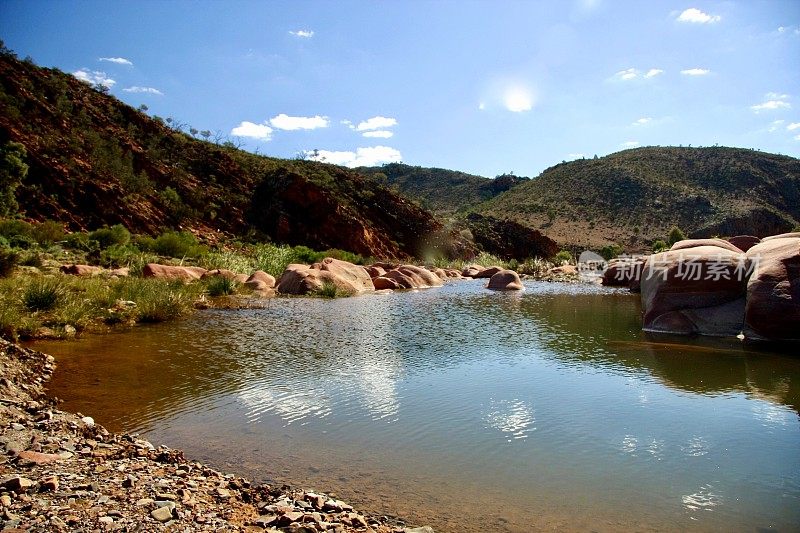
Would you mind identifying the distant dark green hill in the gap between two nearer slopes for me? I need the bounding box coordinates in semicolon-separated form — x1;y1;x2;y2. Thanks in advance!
356;163;528;215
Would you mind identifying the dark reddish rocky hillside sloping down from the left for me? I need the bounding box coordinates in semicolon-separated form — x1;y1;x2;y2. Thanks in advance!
0;50;472;258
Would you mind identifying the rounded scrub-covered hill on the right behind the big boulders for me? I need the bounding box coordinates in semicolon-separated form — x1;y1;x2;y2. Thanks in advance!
475;147;800;251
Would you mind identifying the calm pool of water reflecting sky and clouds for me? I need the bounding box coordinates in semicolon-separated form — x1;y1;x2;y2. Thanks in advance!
36;281;800;532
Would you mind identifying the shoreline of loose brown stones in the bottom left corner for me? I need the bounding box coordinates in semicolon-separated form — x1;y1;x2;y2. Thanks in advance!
0;339;433;533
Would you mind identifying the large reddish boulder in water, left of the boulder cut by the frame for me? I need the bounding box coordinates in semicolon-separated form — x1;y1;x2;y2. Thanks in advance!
641;243;749;335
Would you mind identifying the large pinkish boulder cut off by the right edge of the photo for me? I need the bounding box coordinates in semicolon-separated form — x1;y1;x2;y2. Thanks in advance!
744;233;800;340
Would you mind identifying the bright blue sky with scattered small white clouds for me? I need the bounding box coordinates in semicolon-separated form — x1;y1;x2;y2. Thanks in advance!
0;0;800;176
